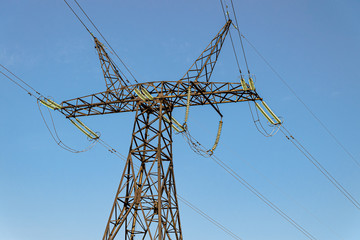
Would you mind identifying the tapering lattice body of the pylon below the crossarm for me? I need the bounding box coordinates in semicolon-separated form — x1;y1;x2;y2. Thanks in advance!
103;100;182;240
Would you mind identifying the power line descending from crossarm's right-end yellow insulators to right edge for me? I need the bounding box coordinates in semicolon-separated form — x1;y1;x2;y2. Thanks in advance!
280;126;360;210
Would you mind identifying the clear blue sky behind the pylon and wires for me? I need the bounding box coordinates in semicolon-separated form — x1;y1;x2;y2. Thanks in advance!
0;0;360;240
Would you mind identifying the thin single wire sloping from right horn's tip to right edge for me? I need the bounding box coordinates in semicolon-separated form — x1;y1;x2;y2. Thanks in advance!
241;34;360;168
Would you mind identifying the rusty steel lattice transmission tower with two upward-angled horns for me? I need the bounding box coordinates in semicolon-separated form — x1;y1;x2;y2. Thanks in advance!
55;20;270;240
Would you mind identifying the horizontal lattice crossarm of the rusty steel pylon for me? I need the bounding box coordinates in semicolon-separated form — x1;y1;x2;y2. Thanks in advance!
59;81;261;117
